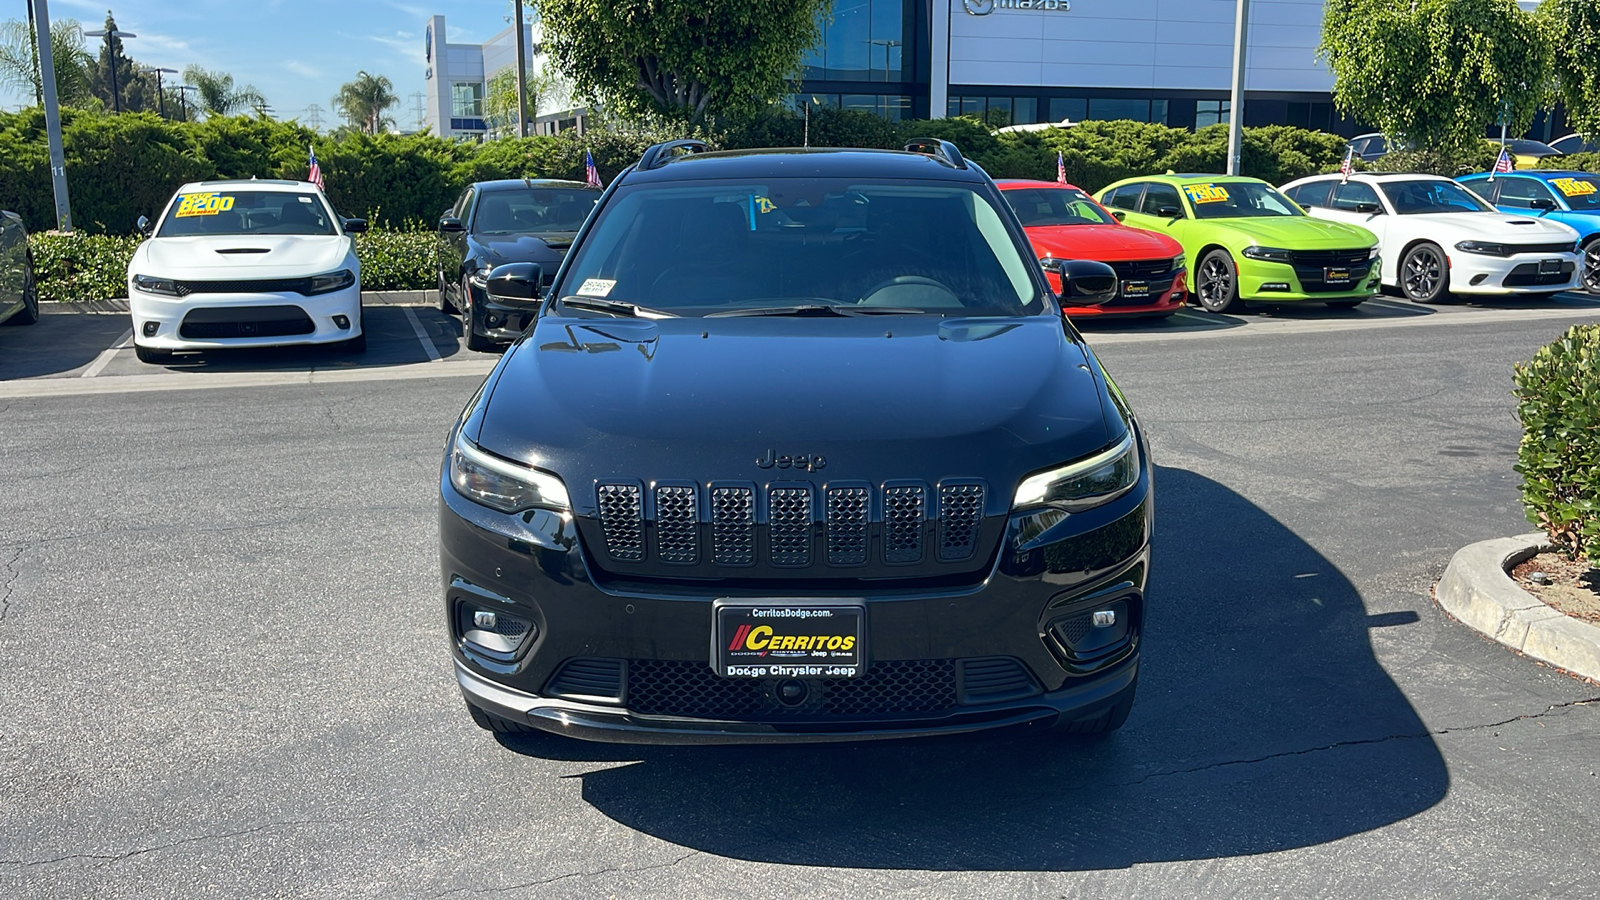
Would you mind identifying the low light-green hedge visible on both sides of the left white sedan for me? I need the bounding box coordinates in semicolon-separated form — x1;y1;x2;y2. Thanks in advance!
27;229;438;303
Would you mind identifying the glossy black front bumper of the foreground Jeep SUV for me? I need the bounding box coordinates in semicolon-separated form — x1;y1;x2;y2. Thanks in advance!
440;425;1152;743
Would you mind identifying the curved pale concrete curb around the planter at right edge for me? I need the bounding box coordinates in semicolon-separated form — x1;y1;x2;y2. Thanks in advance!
1434;533;1600;681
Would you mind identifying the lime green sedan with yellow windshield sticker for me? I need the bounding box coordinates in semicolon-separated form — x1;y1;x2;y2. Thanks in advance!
1099;173;1381;312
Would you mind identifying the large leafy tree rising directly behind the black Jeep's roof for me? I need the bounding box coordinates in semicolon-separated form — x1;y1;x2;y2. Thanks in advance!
539;0;832;122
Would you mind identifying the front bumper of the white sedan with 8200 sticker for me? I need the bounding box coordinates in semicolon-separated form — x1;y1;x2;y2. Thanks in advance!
128;280;362;351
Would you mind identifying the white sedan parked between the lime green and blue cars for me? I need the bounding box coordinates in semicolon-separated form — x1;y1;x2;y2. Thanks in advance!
1283;175;1582;303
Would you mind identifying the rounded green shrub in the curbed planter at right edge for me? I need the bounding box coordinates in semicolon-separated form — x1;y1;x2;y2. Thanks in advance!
1514;325;1600;562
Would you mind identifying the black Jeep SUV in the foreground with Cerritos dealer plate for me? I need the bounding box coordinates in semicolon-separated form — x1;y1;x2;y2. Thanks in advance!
438;141;1152;743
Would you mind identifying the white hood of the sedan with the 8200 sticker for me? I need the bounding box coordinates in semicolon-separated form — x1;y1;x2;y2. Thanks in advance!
131;234;355;279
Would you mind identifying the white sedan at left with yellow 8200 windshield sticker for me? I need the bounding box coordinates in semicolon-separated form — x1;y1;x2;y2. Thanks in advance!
128;179;366;362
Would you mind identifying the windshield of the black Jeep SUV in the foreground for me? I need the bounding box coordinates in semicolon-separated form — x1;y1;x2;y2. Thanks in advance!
560;178;1045;315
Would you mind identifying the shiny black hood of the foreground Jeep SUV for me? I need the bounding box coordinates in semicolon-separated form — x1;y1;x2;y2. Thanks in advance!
469;315;1123;514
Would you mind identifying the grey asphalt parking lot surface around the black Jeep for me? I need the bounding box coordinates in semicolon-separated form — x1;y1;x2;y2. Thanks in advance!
0;295;1600;900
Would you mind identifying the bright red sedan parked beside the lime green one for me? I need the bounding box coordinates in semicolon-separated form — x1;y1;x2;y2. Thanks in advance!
995;178;1189;317
